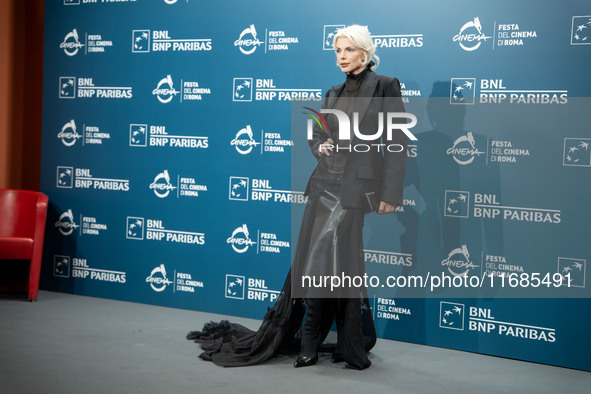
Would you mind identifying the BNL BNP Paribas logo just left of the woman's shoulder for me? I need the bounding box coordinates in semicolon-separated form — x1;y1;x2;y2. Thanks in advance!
232;78;322;102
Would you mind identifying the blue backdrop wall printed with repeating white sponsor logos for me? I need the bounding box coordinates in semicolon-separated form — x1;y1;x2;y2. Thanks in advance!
41;0;591;370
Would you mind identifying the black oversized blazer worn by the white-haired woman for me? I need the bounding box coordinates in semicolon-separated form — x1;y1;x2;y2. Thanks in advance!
305;71;407;208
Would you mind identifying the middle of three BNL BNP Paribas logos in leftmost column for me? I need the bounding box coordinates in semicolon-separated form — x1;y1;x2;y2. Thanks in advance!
56;166;129;192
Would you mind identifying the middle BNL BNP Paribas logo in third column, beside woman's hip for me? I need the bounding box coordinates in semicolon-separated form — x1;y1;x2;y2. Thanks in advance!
228;176;308;204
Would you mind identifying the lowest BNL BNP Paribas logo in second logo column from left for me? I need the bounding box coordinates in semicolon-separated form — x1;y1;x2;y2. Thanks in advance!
125;216;205;245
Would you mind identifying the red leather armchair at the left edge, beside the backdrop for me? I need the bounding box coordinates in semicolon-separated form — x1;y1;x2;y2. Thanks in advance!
0;189;48;301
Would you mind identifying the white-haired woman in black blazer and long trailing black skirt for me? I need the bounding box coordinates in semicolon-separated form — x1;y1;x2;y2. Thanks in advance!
187;25;406;369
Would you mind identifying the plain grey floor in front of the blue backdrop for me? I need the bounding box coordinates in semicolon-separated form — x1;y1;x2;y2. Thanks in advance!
0;291;591;394
